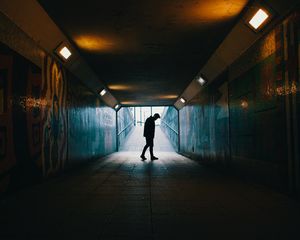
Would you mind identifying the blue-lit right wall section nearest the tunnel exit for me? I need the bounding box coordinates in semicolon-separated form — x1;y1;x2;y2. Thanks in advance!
179;74;229;166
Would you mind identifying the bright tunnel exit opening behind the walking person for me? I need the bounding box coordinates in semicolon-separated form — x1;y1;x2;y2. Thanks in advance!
117;106;179;156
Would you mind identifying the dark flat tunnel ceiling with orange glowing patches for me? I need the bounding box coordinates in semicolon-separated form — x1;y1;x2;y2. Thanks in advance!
39;0;248;105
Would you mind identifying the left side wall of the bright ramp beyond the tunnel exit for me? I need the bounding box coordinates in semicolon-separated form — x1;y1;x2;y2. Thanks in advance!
117;107;134;147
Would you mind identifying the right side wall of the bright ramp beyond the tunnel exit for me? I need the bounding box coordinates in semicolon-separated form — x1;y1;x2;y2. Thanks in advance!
160;107;179;150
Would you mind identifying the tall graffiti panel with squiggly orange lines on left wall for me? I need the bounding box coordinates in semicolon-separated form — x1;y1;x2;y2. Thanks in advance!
41;57;67;176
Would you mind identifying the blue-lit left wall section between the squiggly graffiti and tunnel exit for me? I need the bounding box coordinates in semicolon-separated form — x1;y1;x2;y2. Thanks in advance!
68;71;116;166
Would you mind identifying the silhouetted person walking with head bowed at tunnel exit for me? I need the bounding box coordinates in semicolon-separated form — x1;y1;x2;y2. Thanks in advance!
141;113;160;161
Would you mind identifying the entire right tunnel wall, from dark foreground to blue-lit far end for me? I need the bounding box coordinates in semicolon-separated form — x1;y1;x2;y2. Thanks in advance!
180;10;300;191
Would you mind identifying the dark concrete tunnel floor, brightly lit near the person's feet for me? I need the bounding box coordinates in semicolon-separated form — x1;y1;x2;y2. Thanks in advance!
0;152;300;240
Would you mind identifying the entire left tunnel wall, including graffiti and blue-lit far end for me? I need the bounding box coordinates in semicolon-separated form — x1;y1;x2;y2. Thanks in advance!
0;44;116;194
